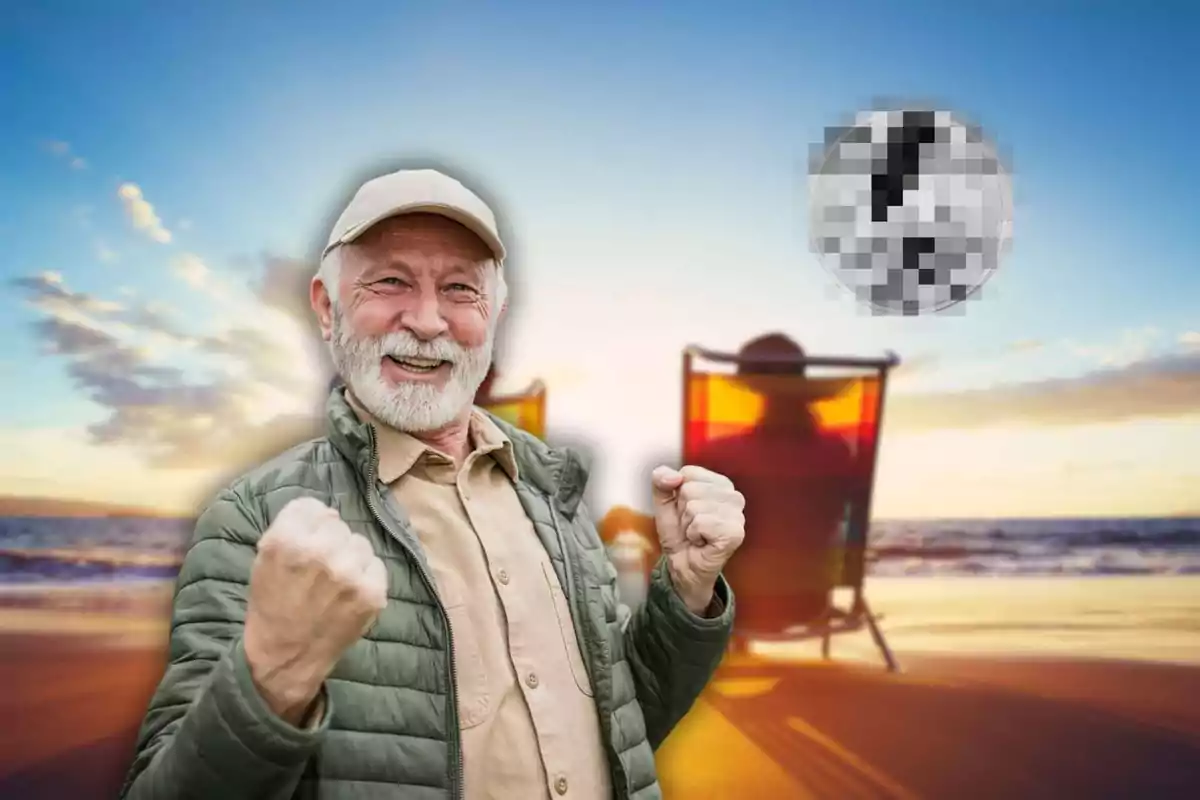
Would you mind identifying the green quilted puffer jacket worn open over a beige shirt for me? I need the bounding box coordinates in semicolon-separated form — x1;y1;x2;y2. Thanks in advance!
121;389;734;800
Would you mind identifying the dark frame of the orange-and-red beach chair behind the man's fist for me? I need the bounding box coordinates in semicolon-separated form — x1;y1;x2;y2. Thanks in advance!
680;345;900;672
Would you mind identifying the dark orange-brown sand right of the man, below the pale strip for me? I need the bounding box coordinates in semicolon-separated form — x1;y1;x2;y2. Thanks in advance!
659;654;1200;800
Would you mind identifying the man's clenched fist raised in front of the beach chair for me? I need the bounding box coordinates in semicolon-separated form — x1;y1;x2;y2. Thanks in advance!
650;467;745;614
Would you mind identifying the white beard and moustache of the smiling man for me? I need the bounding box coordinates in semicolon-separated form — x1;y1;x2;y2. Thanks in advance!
329;305;496;433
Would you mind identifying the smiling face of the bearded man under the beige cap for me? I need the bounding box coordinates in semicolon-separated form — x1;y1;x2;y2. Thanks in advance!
314;213;500;433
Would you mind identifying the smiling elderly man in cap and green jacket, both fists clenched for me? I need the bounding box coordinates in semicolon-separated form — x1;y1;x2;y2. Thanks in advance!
122;165;744;800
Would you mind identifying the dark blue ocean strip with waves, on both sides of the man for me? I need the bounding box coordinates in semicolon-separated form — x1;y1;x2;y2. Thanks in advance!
0;517;1200;585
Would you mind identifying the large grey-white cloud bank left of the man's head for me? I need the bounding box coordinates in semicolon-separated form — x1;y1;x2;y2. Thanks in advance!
13;263;328;482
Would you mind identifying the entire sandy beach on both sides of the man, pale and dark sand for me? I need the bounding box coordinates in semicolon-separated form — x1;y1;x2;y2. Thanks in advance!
0;577;1200;800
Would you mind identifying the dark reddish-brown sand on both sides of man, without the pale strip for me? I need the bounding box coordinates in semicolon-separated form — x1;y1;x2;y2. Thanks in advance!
0;634;1200;800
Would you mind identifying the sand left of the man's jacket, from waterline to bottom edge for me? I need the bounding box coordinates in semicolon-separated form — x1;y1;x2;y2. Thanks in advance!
0;582;172;800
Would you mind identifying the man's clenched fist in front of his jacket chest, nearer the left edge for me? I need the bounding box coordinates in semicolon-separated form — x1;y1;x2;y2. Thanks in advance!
244;498;388;724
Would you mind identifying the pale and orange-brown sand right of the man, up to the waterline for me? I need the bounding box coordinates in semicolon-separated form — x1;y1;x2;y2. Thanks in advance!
659;576;1200;800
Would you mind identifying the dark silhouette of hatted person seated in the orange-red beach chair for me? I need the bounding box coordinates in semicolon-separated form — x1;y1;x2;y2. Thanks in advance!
691;333;856;636
